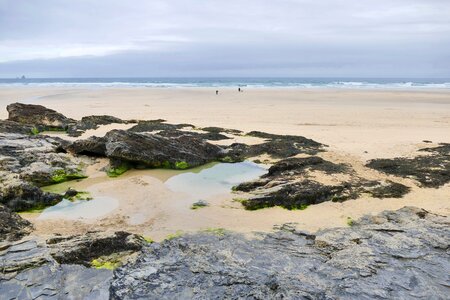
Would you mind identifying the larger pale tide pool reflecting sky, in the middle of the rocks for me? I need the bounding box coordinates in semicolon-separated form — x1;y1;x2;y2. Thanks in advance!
165;161;267;199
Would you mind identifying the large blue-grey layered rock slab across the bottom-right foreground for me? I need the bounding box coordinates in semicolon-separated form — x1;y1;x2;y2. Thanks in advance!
110;208;450;299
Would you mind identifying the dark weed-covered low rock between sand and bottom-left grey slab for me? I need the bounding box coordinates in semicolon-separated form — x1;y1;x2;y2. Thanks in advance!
47;231;145;266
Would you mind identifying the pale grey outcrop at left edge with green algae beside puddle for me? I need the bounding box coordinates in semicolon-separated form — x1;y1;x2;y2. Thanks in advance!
0;133;90;211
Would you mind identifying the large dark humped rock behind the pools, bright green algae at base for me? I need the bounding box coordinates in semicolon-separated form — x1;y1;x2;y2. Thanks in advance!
67;129;223;169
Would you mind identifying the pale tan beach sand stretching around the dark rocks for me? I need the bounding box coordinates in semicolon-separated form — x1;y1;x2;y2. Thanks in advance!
0;87;450;239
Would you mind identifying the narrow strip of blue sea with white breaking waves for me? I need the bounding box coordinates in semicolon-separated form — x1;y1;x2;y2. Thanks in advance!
0;77;450;89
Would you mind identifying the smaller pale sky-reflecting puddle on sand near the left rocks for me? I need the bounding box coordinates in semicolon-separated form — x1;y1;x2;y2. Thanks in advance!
38;197;119;220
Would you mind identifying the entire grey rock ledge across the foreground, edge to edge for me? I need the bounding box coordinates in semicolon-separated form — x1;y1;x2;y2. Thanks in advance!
0;207;450;299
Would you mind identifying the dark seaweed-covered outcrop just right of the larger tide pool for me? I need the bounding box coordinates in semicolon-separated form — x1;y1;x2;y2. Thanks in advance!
234;156;410;210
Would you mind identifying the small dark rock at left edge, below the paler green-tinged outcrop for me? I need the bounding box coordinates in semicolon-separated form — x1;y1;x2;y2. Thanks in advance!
0;204;32;242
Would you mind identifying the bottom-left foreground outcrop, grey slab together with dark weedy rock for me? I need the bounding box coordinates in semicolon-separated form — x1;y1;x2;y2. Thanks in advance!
0;232;143;299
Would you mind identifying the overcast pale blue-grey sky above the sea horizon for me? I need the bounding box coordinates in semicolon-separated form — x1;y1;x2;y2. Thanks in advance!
0;0;450;78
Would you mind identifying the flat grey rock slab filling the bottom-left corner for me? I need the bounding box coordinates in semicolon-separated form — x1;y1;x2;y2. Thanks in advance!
0;239;112;299
